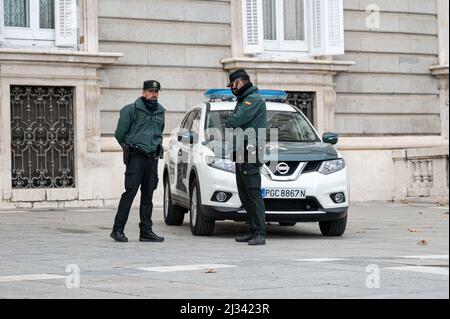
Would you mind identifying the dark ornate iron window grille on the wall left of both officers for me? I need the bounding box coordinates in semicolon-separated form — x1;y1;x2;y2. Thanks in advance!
11;86;75;189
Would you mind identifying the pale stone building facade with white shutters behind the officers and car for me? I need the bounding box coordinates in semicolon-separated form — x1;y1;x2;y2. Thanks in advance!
0;0;449;208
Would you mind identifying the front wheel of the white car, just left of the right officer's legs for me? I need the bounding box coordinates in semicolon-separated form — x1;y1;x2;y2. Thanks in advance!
190;180;216;236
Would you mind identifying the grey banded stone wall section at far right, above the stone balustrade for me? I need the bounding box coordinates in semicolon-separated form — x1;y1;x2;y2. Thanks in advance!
336;0;441;136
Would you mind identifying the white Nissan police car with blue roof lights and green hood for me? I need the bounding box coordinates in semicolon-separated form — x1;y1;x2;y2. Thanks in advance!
163;90;349;236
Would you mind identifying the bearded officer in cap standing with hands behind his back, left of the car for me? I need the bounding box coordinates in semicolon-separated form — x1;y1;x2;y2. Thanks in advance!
110;81;165;242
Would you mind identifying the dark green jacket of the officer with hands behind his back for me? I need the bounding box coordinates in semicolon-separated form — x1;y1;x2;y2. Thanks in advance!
115;98;166;153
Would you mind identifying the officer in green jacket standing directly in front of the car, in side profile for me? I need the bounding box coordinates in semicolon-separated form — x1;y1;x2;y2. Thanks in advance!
226;69;267;245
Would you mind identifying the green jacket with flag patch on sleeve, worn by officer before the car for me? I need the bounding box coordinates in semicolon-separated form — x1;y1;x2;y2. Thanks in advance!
226;87;267;164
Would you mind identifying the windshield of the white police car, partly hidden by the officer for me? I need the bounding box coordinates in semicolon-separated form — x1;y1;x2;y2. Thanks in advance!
205;111;320;143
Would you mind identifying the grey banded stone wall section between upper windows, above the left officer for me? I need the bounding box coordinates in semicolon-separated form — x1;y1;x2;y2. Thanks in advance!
99;0;231;136
